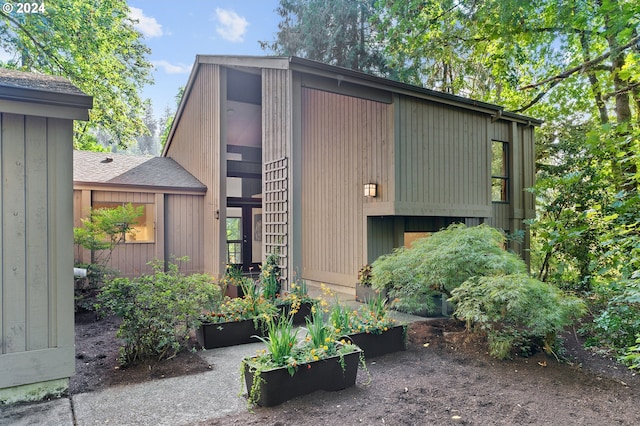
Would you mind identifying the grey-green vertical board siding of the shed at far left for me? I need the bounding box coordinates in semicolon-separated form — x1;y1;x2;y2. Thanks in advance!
0;113;74;388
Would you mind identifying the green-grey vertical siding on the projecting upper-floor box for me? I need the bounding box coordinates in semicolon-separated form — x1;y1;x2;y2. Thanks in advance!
395;97;491;217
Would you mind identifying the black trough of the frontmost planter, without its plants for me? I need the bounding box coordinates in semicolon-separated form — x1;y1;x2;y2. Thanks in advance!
242;350;361;407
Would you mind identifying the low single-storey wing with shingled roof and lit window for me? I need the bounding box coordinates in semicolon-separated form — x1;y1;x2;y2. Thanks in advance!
73;151;207;277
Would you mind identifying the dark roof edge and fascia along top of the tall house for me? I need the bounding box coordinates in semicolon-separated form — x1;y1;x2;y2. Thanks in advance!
162;55;542;155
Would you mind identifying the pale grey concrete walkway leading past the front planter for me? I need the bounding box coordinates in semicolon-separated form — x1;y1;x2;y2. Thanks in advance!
0;302;425;426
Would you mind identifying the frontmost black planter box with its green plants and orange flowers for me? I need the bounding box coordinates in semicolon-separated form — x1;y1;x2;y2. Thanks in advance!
241;308;364;406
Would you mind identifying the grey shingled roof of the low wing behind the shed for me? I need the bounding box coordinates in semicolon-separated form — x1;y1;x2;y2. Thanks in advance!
73;151;207;194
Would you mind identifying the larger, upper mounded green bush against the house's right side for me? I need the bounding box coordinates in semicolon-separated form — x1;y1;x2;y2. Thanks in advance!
371;224;526;312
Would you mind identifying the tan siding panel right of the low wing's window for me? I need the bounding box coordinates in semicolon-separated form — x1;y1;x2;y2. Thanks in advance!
165;195;205;274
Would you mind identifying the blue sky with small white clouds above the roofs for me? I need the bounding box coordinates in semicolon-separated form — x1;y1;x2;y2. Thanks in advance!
128;0;280;117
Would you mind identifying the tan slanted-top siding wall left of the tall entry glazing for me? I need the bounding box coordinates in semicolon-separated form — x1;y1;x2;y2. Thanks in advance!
167;64;226;275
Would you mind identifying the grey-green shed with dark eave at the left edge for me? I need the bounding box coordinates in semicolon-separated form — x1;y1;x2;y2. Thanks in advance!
0;69;93;405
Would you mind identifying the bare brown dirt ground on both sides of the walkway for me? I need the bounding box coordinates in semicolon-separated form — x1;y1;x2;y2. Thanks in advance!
71;314;640;426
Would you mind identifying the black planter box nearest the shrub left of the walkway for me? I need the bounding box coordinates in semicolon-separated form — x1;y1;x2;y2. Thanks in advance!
196;319;264;349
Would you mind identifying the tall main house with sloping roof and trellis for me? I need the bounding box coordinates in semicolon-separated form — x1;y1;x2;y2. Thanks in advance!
163;56;540;293
